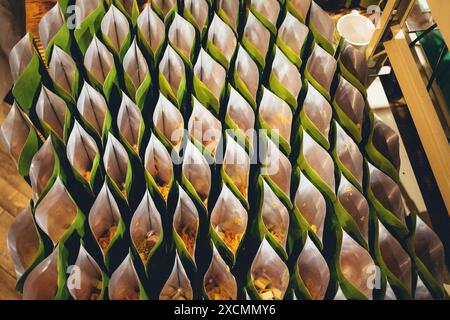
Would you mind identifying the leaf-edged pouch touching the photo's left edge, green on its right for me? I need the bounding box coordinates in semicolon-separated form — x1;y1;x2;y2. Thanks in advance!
0;103;41;177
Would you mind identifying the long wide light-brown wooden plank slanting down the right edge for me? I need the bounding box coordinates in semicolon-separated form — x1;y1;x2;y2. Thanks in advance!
384;26;450;212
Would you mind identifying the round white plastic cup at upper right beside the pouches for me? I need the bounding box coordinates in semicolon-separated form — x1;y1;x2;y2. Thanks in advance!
337;10;375;54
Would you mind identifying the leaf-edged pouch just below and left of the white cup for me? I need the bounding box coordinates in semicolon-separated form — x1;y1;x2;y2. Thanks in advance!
305;44;337;101
